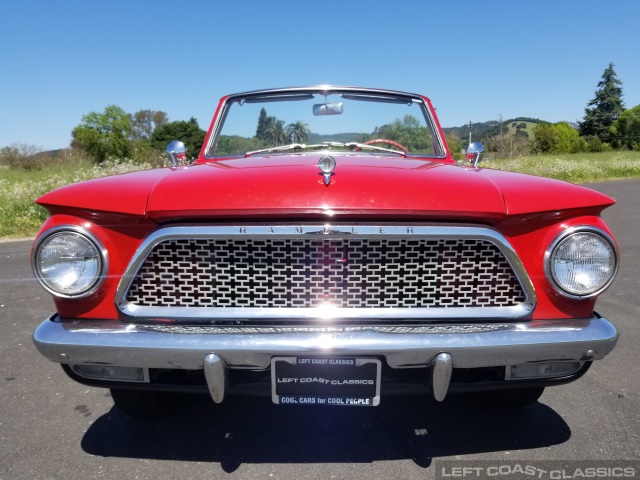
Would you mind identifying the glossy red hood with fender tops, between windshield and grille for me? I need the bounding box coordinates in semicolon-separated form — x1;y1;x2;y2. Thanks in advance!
38;153;614;223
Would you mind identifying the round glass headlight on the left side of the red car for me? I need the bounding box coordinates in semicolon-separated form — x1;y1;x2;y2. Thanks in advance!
33;227;106;298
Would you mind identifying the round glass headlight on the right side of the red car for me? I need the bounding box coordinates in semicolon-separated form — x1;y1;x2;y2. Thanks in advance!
545;227;618;298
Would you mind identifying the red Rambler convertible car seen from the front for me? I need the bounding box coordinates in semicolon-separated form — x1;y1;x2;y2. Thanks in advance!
32;86;618;415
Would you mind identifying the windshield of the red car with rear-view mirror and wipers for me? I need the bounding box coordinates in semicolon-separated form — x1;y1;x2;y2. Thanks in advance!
206;91;445;157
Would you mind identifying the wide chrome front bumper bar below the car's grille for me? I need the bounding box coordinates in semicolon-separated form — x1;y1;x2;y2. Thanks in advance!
33;315;618;369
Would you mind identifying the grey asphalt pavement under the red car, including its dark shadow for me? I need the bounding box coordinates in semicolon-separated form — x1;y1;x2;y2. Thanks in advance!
0;180;640;480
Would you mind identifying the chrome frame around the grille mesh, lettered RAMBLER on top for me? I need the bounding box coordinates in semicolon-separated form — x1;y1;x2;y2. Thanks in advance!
115;224;536;323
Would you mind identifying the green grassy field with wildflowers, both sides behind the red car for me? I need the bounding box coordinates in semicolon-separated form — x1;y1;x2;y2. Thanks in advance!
0;151;640;238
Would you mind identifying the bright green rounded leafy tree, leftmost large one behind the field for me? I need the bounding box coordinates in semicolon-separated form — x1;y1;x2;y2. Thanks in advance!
71;105;131;163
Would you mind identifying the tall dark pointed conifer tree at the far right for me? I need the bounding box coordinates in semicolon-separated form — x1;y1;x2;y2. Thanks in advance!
580;63;624;141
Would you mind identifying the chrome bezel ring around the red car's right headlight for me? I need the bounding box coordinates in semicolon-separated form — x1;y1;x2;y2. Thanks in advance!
544;225;620;300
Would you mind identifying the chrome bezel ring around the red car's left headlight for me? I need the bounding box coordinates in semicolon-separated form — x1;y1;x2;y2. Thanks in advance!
31;225;109;299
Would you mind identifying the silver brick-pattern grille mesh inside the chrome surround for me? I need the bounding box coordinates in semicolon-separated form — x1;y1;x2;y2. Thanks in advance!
126;238;525;308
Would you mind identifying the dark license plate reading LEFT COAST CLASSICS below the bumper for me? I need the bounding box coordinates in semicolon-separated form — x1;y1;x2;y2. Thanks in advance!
271;357;380;407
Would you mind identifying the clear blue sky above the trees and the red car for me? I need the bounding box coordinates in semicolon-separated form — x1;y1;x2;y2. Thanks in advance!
0;0;640;150
